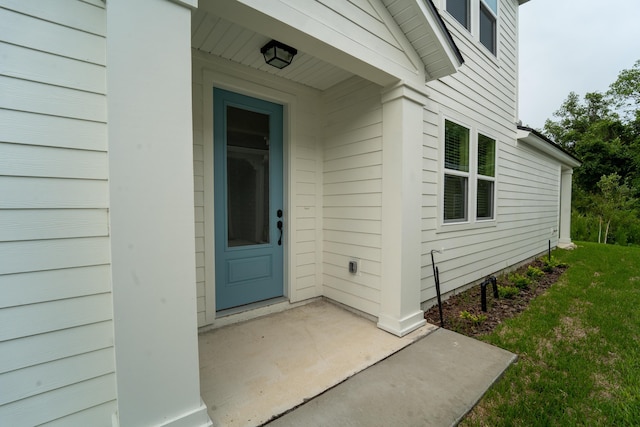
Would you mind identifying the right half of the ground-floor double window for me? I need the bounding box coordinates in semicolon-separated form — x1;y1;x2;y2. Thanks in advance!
476;134;496;220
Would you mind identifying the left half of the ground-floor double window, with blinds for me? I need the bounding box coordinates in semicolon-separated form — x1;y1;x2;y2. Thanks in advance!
444;120;470;222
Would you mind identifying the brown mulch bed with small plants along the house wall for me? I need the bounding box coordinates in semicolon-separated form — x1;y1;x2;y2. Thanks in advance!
424;258;567;338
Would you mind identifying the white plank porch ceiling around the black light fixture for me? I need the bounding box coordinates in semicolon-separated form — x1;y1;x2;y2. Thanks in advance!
191;9;353;90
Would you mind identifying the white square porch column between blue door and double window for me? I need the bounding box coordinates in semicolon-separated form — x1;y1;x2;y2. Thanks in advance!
378;84;426;336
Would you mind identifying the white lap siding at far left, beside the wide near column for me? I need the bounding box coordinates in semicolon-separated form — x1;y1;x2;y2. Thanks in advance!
0;0;116;426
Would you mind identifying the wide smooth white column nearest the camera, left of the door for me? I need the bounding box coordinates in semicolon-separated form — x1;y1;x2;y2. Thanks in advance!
106;0;211;427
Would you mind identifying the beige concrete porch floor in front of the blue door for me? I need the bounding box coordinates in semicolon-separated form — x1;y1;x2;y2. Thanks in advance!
199;300;436;426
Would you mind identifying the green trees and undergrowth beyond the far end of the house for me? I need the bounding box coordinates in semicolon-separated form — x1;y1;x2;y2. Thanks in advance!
543;60;640;244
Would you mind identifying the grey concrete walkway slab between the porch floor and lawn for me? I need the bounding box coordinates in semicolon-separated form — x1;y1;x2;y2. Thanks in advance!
268;329;516;427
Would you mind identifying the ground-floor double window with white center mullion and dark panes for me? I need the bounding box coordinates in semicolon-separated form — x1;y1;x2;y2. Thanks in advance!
442;119;496;224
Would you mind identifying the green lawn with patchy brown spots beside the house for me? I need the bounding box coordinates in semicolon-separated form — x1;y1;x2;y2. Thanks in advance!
460;243;640;427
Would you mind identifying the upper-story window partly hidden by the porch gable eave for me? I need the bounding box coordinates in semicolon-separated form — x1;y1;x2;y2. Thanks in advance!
445;0;498;55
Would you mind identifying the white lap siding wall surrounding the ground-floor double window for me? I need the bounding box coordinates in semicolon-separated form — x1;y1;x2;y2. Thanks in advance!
421;0;560;301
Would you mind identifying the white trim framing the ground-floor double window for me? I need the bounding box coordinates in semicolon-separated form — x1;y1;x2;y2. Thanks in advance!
436;114;500;233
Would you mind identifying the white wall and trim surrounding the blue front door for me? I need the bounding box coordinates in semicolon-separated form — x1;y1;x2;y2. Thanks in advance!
193;51;322;326
